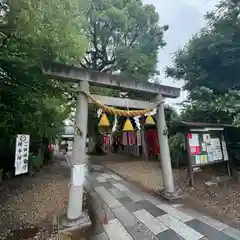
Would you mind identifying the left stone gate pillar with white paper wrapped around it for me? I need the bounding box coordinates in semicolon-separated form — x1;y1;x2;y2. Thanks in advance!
64;81;89;224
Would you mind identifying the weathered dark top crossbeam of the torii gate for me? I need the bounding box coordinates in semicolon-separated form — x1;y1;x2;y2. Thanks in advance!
42;63;180;99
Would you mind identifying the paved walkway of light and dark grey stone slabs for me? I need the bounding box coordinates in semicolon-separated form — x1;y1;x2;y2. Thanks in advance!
85;166;240;240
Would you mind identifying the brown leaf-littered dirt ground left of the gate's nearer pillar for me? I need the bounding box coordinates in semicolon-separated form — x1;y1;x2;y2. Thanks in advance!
0;155;88;240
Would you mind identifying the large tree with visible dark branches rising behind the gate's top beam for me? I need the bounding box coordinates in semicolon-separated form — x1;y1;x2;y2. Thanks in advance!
81;0;168;80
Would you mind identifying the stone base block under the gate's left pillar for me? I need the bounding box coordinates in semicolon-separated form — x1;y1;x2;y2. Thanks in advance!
58;211;92;232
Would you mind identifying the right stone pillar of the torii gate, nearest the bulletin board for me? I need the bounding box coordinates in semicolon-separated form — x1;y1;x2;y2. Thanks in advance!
157;94;175;196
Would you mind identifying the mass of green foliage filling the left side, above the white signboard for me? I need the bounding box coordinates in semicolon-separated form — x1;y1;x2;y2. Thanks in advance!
0;0;87;165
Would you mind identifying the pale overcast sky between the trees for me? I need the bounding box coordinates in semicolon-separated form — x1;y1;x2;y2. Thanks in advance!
143;0;218;108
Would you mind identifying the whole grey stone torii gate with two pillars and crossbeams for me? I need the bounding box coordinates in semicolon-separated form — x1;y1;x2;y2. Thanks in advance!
42;63;180;226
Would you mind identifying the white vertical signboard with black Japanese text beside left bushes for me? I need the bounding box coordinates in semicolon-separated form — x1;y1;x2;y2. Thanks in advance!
14;134;30;175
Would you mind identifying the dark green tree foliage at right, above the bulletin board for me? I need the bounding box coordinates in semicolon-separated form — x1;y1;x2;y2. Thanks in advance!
166;0;240;124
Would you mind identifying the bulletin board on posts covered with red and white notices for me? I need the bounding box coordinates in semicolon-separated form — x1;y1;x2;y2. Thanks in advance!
187;131;230;185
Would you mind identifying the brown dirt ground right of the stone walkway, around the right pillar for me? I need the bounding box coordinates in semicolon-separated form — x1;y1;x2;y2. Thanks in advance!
102;154;240;228
